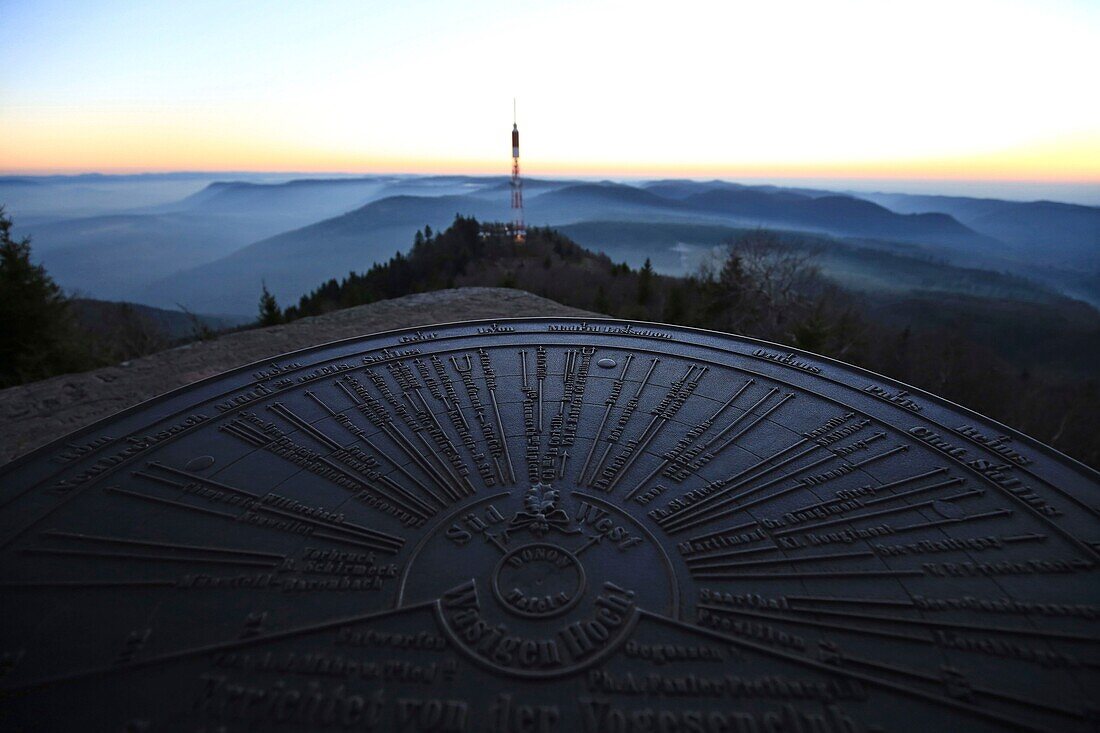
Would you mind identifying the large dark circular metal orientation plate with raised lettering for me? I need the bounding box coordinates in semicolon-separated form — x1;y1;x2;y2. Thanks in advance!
0;319;1100;733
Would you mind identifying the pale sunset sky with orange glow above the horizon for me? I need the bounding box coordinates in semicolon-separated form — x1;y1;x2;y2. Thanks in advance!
0;0;1100;190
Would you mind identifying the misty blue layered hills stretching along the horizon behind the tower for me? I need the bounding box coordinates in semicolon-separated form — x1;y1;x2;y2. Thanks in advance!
10;176;1100;314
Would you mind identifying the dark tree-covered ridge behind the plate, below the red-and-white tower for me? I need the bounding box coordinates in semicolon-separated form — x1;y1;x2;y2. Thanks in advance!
277;216;1100;466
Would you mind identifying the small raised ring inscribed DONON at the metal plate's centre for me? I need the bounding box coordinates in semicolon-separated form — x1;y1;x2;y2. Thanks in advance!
493;543;585;619
